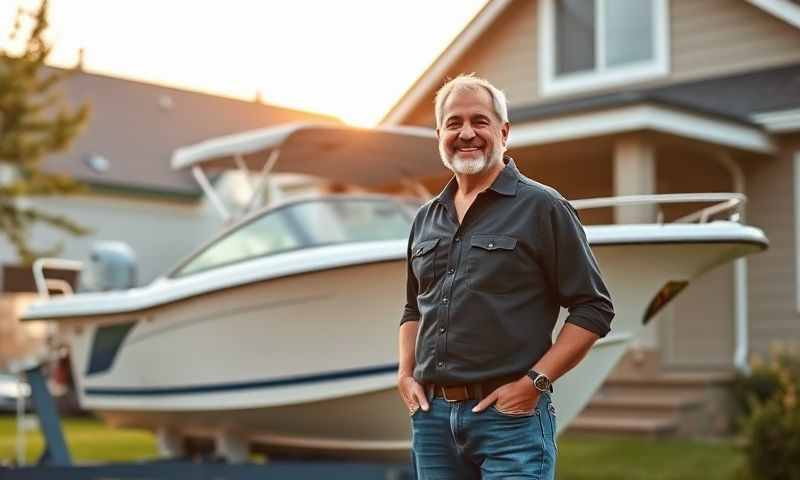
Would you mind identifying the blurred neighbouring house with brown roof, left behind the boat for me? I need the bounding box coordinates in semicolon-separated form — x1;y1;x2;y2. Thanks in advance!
0;66;340;369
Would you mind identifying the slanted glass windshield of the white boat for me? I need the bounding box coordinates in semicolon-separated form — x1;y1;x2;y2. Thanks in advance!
170;198;419;277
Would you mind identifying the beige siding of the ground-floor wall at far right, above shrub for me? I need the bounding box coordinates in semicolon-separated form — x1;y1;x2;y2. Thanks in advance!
747;139;800;354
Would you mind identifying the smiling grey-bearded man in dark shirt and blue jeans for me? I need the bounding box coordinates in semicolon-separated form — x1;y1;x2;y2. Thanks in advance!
398;75;614;480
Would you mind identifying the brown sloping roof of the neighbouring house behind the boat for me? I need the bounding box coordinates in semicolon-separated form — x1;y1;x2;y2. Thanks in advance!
42;67;341;198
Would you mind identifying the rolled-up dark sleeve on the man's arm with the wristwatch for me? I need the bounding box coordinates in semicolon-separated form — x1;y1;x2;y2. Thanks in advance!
540;199;614;337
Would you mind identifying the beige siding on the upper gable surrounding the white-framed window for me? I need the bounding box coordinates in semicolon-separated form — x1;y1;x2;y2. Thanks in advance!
407;0;800;125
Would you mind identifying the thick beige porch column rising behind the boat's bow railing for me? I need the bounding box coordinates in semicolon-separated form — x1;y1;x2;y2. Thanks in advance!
614;136;658;223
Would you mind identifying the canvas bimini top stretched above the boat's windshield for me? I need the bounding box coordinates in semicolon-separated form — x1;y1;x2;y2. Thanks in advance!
172;123;447;187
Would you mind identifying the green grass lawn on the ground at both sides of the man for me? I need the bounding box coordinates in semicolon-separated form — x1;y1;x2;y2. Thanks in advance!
0;416;744;480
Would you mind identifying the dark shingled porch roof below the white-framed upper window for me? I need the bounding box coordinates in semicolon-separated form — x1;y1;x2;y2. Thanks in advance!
509;63;800;126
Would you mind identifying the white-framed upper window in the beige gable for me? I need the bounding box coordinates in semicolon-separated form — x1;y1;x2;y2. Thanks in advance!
539;0;669;95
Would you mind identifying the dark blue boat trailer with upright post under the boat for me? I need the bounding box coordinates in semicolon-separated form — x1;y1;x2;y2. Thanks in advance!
0;365;414;480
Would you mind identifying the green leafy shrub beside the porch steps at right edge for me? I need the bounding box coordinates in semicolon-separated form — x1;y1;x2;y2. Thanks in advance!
737;347;800;480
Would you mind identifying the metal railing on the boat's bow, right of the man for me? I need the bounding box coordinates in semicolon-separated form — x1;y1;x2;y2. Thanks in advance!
570;193;747;223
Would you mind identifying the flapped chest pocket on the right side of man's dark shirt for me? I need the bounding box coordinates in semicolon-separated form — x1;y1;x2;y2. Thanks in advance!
467;233;525;293
